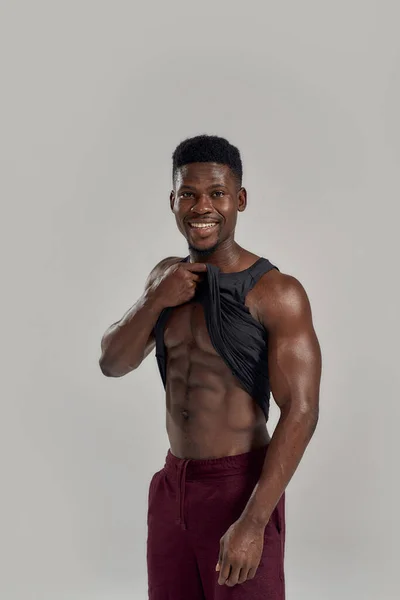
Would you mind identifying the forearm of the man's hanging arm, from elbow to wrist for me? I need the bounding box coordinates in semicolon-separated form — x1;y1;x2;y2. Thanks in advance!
241;408;318;527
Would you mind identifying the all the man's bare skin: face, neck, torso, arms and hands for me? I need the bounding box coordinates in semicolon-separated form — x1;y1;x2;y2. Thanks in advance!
100;163;321;586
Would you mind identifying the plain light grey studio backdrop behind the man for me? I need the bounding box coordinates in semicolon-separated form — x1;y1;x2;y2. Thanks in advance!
0;0;400;600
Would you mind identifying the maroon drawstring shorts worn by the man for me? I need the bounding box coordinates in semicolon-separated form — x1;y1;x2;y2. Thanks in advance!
147;446;285;600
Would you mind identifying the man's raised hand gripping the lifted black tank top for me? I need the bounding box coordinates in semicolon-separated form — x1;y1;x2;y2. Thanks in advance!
149;262;207;308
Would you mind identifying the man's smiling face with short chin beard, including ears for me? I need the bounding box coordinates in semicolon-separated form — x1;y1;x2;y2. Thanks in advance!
170;163;246;254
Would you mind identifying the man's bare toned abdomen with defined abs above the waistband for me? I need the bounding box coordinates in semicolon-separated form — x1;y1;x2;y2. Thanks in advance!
166;340;270;459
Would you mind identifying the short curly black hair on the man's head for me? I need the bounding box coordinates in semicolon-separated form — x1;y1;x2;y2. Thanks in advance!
172;135;243;185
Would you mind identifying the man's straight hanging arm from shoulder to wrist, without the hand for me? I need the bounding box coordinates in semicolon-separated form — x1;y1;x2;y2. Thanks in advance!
242;273;322;527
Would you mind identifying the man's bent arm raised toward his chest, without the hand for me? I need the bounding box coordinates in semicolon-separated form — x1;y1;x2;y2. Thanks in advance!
99;256;181;377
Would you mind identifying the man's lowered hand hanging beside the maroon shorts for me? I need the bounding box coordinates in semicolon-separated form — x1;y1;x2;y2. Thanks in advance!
215;518;265;586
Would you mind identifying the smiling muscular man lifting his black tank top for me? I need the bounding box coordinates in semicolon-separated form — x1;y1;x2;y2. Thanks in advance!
100;135;321;600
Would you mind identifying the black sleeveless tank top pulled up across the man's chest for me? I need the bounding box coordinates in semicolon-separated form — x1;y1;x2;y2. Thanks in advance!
154;256;279;421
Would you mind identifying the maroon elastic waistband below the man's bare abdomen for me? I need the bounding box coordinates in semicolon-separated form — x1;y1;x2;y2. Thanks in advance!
164;444;268;480
